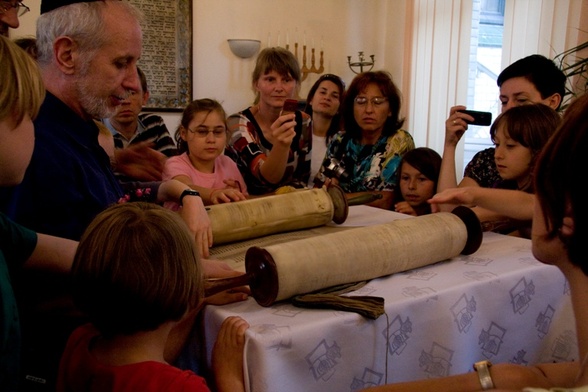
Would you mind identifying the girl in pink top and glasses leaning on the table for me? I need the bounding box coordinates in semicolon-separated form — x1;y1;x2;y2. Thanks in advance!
163;98;248;204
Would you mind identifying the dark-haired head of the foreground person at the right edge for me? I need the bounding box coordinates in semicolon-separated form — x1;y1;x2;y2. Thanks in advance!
532;95;588;275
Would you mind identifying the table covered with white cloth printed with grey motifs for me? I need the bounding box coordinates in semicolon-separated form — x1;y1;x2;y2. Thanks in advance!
203;206;578;392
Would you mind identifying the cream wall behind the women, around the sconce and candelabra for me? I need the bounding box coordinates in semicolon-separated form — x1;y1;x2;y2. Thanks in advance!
10;0;407;133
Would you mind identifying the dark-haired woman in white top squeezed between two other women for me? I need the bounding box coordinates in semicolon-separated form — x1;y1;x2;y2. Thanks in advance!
304;74;345;188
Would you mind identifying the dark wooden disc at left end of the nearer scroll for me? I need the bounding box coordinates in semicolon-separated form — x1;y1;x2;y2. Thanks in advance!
245;246;279;306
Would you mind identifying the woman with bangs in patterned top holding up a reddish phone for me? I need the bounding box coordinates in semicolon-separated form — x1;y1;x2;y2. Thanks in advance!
225;47;312;195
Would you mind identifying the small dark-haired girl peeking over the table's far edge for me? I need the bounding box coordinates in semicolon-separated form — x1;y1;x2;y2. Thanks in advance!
394;147;441;216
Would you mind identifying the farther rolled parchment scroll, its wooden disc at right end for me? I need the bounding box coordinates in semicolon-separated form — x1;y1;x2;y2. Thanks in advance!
208;186;349;245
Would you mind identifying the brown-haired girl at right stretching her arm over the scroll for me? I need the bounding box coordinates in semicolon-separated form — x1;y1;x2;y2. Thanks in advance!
433;103;561;238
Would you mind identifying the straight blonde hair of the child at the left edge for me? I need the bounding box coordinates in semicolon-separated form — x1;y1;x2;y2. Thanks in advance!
0;36;45;125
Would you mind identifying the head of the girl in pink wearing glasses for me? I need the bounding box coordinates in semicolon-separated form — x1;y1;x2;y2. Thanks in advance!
175;98;227;161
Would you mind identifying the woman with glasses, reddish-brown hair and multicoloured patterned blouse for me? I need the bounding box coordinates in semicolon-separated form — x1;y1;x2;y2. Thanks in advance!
317;71;414;209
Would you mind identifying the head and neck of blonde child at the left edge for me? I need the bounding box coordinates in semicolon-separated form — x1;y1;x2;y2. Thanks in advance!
0;36;45;186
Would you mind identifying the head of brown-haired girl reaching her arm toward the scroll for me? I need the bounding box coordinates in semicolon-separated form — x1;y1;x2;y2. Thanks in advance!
490;103;561;188
